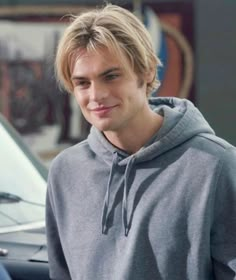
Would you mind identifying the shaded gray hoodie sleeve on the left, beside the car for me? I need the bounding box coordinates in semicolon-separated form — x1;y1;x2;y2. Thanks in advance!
46;179;71;280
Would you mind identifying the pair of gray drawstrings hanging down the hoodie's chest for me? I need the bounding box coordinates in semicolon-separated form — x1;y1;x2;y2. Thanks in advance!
102;152;135;236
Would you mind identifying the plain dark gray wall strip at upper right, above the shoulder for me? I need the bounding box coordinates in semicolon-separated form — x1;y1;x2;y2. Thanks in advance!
194;0;236;145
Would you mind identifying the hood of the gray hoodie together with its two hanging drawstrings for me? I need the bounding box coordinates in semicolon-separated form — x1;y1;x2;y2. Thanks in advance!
88;97;214;235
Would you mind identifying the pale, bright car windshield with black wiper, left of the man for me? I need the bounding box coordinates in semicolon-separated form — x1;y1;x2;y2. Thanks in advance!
0;119;46;231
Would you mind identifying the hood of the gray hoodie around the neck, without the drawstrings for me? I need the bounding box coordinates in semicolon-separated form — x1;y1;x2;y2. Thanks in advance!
88;97;214;165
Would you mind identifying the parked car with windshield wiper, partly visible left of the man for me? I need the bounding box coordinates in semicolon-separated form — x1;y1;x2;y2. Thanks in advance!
0;114;49;280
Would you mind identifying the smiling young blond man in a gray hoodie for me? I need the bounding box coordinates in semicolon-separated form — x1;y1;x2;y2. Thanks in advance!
46;2;236;280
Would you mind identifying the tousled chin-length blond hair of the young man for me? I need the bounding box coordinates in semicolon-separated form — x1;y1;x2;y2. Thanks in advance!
55;4;161;94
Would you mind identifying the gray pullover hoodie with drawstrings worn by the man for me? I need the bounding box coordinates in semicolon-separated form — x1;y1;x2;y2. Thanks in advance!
46;98;236;280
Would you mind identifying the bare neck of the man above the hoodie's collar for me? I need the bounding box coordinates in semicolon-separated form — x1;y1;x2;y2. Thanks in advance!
104;110;163;154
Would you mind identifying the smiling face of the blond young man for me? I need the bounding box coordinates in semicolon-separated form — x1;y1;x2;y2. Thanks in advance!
71;49;152;133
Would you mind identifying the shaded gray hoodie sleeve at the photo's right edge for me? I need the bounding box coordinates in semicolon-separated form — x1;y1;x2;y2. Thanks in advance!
211;147;236;280
